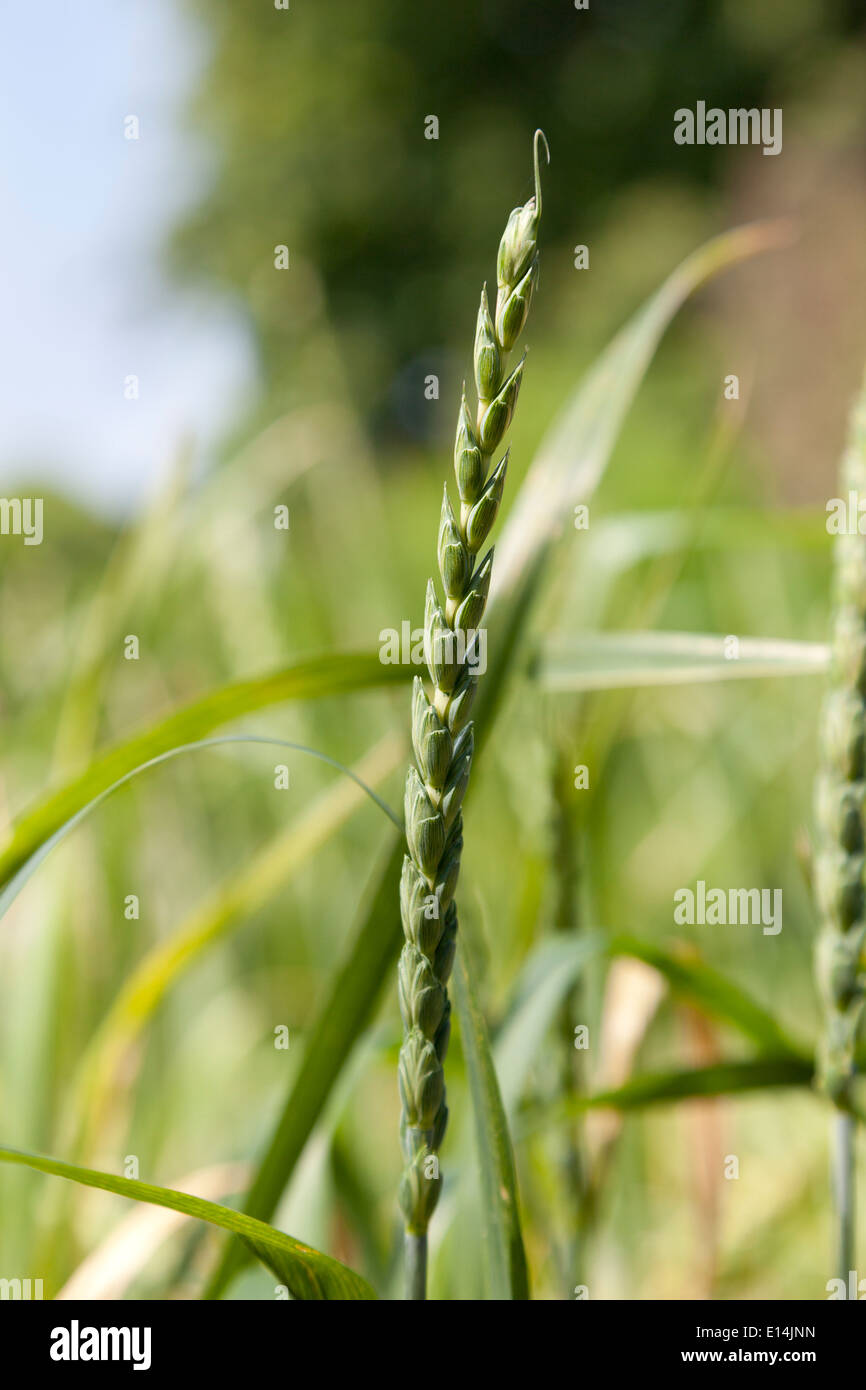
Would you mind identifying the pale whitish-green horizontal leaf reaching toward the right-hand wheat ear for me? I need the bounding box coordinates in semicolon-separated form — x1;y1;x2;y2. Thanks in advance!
532;632;830;694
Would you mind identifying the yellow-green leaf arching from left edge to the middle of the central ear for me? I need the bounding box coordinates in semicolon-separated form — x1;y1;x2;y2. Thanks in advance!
0;652;413;885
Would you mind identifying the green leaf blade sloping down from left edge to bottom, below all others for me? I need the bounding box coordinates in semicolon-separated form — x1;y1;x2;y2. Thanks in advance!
0;1148;377;1301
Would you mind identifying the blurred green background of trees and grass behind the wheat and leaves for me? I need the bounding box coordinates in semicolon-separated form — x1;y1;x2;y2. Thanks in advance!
0;0;866;1298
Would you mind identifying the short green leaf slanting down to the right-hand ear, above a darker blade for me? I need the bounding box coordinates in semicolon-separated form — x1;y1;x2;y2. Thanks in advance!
609;935;809;1062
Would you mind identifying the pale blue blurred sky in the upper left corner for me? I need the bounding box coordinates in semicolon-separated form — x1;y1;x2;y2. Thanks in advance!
0;0;254;514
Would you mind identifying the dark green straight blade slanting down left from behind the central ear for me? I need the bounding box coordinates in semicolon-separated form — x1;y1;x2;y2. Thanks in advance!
204;837;403;1298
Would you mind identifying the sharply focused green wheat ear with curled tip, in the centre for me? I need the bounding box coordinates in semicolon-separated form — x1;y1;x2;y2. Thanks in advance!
399;131;549;1298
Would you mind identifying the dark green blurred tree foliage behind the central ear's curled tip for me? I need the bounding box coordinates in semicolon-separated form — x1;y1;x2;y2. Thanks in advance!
172;0;855;447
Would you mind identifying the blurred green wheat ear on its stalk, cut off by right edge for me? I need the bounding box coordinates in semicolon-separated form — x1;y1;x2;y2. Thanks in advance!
815;369;866;1279
